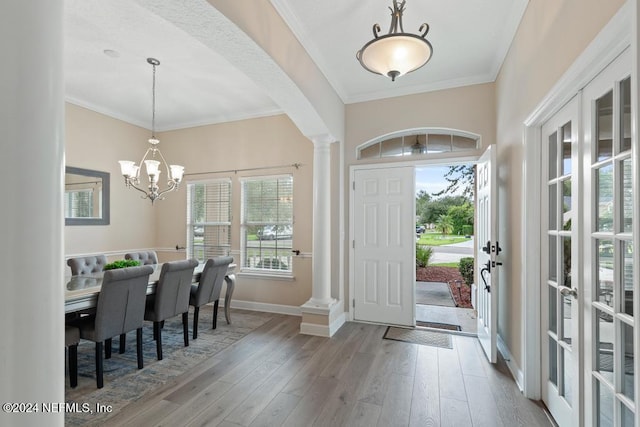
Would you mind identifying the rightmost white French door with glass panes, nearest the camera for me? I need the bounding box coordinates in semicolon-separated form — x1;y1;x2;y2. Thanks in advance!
582;50;638;427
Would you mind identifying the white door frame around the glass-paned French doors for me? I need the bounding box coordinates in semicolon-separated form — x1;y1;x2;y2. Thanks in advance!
520;0;640;400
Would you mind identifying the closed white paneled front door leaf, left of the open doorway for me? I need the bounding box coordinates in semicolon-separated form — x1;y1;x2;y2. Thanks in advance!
353;167;416;326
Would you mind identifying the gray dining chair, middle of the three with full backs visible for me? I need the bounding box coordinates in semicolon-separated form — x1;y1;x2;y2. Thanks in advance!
144;259;198;360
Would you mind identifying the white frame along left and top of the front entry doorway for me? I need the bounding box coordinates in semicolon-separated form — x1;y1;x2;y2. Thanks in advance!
347;155;486;321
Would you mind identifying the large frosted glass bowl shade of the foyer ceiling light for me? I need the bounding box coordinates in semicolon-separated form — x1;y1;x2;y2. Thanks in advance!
357;33;433;79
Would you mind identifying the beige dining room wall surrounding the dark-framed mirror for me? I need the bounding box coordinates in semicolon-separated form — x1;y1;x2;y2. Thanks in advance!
64;103;155;256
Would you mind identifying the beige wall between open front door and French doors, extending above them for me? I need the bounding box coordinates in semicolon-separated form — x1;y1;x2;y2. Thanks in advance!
496;0;624;368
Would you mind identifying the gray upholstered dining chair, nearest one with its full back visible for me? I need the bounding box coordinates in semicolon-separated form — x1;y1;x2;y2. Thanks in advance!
73;266;153;388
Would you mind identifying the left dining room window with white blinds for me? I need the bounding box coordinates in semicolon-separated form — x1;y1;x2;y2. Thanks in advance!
187;179;231;261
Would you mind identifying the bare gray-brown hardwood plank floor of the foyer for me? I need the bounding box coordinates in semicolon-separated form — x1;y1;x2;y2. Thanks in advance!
109;314;551;427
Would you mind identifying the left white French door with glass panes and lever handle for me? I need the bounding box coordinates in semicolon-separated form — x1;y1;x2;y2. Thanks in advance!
540;96;583;426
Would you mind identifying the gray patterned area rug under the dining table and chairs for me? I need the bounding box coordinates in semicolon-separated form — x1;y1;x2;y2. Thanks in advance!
65;306;271;426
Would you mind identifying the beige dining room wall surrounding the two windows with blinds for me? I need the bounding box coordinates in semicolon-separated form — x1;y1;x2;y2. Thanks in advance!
142;115;313;306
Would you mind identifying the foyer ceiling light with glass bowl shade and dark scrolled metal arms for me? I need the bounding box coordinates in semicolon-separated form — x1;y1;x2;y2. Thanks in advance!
356;0;433;81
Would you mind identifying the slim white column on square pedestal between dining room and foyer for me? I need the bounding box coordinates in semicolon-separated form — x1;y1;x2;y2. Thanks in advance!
300;135;344;336
